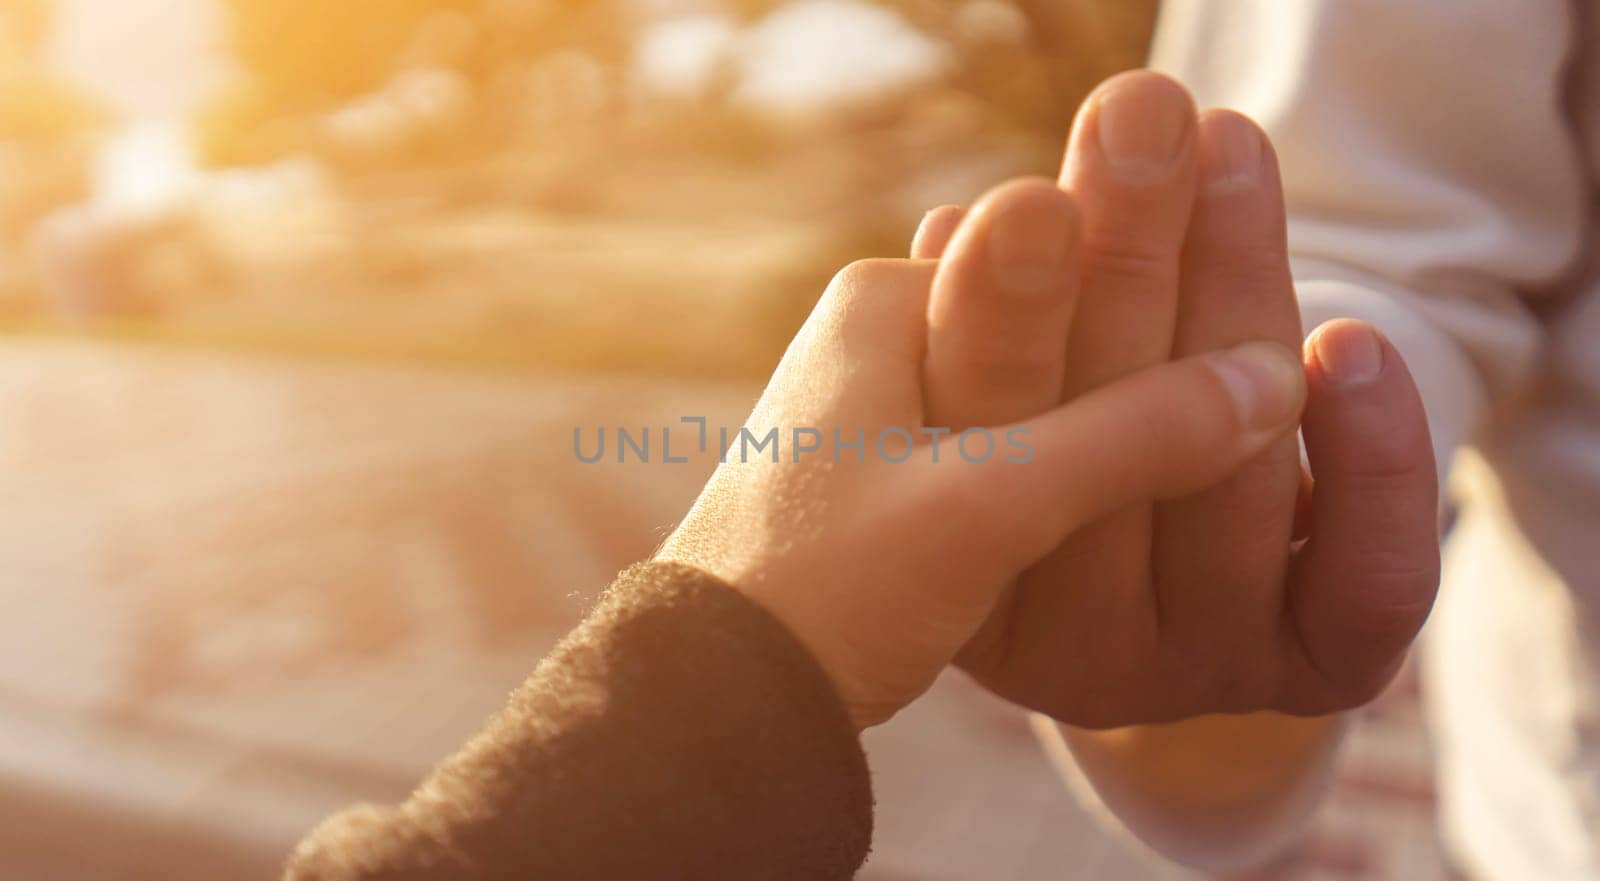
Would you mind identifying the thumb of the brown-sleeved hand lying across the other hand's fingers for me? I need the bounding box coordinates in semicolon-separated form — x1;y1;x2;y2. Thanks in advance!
957;342;1306;568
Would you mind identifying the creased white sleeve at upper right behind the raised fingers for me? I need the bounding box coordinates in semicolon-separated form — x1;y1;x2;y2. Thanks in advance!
1152;0;1587;479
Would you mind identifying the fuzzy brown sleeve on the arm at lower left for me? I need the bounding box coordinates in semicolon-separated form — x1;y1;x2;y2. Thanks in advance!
285;563;872;881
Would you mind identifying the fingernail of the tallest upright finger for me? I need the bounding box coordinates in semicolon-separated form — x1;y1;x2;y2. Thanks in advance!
1094;80;1192;179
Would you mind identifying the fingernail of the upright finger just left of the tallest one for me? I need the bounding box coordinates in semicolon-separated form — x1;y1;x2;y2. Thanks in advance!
989;190;1077;294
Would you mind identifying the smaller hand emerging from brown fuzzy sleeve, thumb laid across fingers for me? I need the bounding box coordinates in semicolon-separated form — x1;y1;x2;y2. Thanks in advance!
658;201;1304;728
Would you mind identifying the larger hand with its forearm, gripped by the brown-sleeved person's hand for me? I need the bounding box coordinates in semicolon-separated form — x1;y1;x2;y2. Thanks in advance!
912;72;1438;867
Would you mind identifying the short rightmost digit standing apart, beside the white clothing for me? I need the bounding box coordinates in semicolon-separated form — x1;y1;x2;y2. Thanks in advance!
1282;320;1438;713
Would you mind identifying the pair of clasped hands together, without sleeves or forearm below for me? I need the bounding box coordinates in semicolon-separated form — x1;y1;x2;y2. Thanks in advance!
658;72;1438;729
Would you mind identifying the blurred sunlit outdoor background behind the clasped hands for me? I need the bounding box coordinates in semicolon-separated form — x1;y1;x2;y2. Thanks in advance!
0;0;1445;881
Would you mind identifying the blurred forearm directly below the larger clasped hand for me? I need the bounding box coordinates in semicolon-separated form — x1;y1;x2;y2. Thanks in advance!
1037;713;1346;870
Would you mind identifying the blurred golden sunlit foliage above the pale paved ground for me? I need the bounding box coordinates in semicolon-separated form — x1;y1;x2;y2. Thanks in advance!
0;0;1155;374
